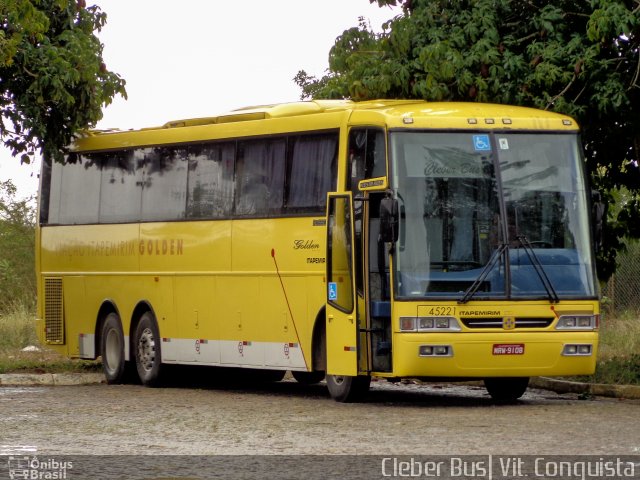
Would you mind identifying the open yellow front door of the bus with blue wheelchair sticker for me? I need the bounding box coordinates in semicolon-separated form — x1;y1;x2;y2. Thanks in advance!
326;192;360;376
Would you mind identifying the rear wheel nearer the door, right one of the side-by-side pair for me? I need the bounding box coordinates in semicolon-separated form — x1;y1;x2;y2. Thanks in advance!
133;312;162;387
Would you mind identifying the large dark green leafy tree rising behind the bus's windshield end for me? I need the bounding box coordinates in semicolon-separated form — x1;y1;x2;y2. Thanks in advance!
295;0;640;279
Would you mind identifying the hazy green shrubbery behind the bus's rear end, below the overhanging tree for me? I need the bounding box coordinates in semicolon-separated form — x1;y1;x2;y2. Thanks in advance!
0;180;36;313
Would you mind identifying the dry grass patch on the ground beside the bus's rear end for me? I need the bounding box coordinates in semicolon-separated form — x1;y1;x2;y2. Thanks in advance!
0;305;102;374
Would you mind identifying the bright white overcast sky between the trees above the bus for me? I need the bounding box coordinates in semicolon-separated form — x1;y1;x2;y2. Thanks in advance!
0;0;400;197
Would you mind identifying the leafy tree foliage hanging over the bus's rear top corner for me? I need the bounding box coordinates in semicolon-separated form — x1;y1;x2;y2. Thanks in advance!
0;0;126;163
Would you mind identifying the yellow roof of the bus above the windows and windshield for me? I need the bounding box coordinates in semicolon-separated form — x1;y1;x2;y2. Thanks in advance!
71;100;578;151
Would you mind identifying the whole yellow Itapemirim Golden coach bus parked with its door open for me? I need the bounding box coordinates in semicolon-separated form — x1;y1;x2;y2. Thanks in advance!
37;100;599;402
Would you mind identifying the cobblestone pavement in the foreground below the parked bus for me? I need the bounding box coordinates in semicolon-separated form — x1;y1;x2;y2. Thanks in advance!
0;374;640;455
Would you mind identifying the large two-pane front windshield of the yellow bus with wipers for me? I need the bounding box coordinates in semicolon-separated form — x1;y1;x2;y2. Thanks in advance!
390;131;596;301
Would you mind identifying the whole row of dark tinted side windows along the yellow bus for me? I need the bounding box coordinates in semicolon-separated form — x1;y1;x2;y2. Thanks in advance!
40;131;338;224
